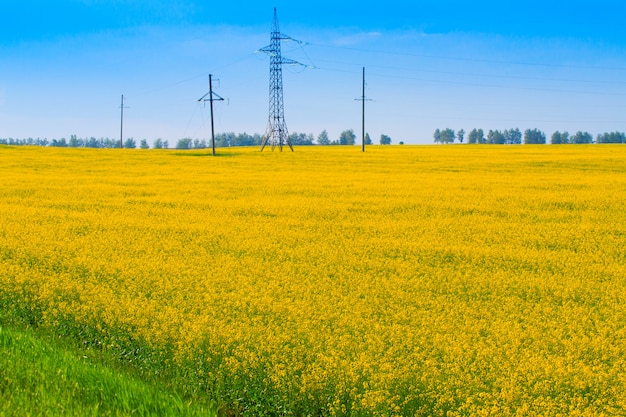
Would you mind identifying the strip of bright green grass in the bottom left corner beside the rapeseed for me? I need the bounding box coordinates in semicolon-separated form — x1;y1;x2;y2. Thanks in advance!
0;326;216;417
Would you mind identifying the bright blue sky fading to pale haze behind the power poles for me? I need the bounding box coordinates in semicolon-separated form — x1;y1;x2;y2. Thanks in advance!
0;0;626;145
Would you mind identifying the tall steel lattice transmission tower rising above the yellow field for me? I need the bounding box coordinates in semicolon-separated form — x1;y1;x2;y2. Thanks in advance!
260;7;306;151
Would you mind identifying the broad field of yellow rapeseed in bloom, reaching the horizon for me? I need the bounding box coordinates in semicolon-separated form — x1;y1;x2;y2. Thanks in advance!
0;145;626;416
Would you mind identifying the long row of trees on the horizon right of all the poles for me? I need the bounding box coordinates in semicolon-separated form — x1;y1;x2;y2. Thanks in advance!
433;128;626;145
